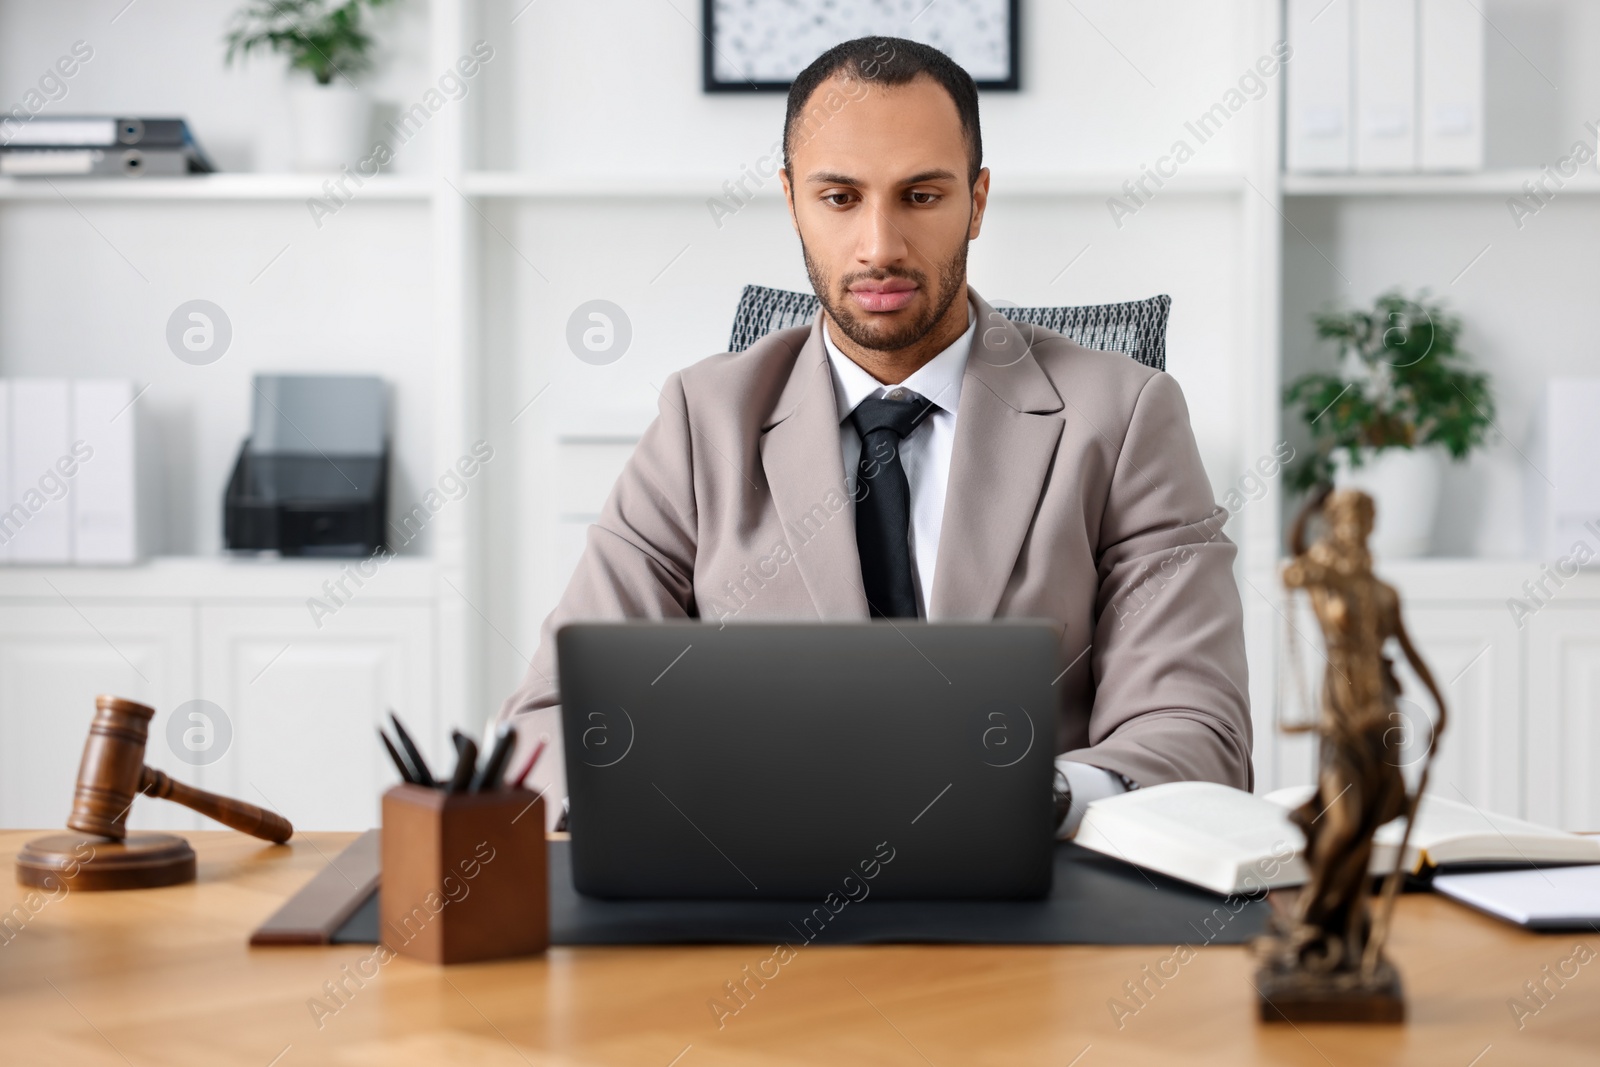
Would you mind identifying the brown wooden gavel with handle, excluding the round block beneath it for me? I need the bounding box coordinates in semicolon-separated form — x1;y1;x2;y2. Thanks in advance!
67;696;294;845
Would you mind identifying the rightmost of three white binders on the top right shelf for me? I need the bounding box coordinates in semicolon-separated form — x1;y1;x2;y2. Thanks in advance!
1418;0;1485;171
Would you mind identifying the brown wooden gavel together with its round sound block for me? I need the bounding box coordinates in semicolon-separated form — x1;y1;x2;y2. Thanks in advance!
16;696;294;889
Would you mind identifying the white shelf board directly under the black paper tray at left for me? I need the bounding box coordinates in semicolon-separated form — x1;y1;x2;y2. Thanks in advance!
0;555;438;605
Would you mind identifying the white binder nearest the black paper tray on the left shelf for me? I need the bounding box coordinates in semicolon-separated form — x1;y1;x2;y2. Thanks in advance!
72;379;139;563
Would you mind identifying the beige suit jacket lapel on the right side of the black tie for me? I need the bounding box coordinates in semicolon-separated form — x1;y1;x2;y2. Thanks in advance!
928;290;1064;619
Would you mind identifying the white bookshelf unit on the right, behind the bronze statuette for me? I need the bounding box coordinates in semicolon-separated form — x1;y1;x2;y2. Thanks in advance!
1246;0;1600;830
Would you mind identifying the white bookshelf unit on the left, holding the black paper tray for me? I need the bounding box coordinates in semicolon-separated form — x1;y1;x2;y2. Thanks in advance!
0;0;491;829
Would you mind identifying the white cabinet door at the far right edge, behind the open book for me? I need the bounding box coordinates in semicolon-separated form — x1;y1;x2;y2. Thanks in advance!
1528;605;1600;830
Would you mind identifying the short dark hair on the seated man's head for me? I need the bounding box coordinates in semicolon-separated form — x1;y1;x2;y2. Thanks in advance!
784;37;984;187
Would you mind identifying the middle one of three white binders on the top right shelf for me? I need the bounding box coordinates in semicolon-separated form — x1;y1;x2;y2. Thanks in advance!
1354;0;1418;173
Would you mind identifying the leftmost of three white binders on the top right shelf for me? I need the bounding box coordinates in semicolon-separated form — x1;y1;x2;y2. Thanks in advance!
1283;0;1354;171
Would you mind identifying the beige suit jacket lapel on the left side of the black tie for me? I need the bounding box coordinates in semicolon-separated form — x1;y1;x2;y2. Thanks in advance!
762;315;869;621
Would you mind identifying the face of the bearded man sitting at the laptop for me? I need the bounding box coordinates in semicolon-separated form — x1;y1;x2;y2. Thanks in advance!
782;77;989;350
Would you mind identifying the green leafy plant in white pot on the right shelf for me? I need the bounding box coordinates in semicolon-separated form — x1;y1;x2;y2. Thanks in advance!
1285;290;1494;558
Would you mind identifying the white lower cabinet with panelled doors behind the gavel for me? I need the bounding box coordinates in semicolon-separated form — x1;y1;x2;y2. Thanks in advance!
0;558;448;830
